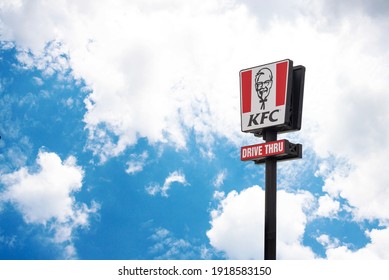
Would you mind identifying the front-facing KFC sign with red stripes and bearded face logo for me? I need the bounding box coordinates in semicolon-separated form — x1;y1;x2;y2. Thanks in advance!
239;59;293;133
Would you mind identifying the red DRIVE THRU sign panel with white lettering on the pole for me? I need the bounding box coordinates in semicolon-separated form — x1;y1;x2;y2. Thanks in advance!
240;140;286;161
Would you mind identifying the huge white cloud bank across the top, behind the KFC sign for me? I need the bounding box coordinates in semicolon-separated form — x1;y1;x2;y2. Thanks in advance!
2;0;388;160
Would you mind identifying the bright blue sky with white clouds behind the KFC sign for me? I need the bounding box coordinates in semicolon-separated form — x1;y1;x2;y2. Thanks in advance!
0;0;389;260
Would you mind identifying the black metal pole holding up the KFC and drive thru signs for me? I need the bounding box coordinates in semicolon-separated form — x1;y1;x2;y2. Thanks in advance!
263;130;277;260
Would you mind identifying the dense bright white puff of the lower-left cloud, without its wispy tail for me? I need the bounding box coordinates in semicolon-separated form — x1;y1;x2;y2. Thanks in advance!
2;152;83;224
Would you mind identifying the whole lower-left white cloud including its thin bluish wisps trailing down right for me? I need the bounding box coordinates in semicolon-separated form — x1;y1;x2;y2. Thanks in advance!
0;151;98;258
